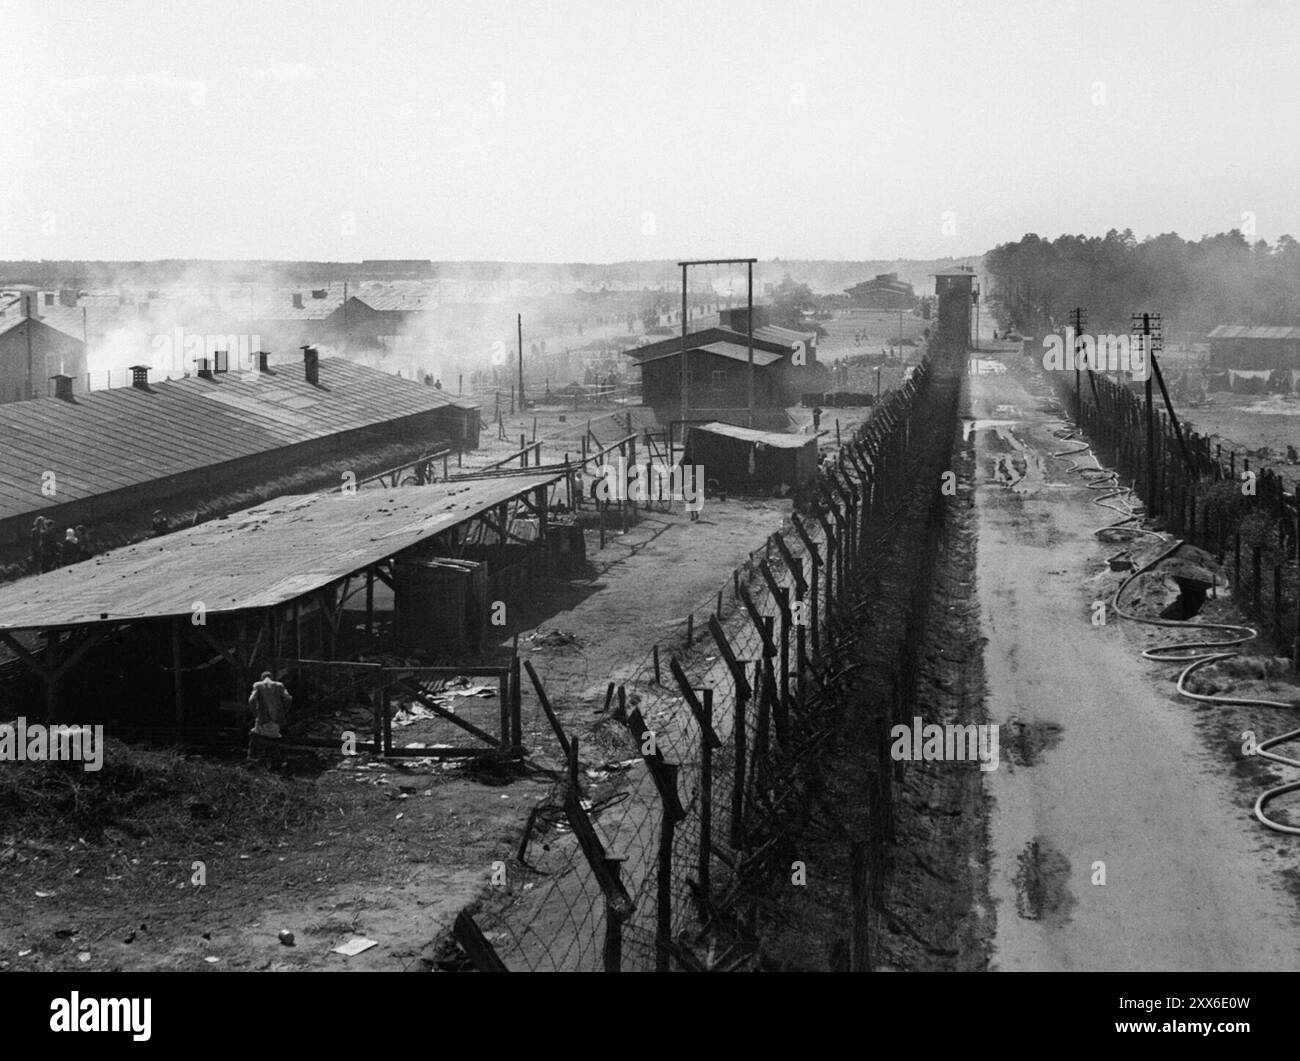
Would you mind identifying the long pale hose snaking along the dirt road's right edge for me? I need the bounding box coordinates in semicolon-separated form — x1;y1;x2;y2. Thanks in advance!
1050;420;1300;836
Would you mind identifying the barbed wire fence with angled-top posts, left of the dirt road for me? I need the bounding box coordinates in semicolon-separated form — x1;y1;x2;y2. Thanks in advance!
441;354;957;971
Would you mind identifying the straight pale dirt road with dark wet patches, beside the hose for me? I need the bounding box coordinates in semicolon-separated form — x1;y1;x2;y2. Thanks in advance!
967;356;1300;970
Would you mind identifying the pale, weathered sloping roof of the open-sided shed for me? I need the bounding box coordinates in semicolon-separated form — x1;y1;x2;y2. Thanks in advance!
0;475;562;631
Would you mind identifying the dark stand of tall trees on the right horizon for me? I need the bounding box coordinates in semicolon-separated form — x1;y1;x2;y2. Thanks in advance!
984;229;1300;339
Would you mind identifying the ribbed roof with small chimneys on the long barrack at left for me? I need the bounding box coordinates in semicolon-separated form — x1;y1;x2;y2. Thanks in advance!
0;358;476;519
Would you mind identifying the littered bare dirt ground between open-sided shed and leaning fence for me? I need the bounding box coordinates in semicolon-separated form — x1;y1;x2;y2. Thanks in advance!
0;421;847;970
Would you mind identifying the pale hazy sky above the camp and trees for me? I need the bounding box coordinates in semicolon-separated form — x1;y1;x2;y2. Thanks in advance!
0;0;1300;261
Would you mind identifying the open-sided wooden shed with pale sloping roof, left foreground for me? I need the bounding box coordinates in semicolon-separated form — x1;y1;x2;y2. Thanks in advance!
0;472;560;733
